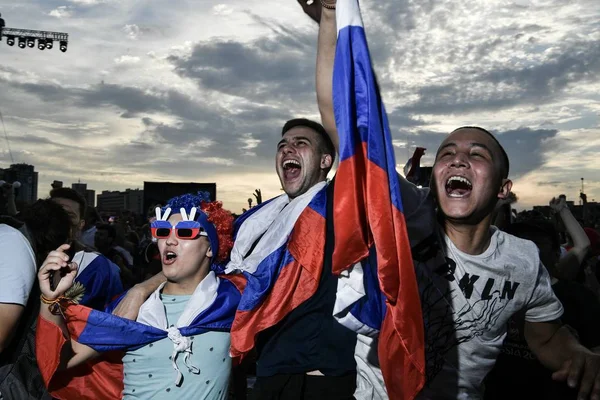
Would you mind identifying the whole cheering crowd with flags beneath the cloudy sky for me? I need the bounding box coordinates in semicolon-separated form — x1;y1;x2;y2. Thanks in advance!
0;0;600;400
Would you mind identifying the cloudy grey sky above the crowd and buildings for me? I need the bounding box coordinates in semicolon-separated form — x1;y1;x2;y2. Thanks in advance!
0;0;600;212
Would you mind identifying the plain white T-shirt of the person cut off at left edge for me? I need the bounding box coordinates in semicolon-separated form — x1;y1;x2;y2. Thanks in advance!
0;224;37;306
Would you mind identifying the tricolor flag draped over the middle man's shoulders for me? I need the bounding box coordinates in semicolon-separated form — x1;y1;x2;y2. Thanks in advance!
226;182;327;358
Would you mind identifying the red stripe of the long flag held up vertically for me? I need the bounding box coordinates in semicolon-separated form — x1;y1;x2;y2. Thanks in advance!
334;143;425;400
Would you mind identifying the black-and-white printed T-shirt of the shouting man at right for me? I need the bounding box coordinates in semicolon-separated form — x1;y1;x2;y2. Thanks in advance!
355;178;562;400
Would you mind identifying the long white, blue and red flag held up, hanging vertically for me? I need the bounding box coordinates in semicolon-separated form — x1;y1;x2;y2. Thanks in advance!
333;0;425;400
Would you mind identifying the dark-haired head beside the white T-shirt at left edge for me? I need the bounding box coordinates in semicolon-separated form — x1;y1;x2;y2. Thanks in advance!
19;199;71;265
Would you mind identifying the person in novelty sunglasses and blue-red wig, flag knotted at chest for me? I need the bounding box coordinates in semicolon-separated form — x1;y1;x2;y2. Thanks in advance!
36;193;240;399
